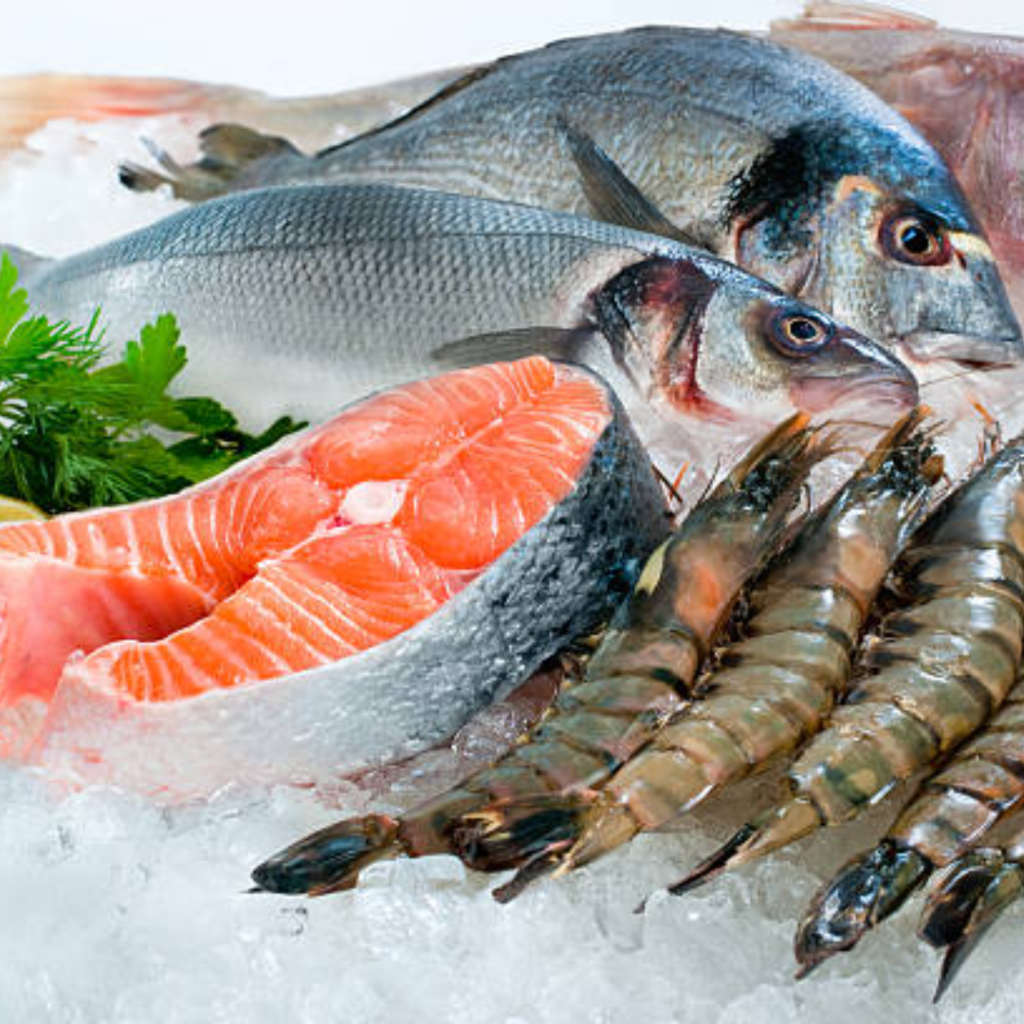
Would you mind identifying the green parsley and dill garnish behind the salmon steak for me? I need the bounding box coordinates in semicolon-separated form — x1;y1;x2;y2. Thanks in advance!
0;254;304;513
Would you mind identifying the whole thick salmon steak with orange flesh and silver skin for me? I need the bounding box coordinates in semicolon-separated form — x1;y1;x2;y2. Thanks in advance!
0;357;670;798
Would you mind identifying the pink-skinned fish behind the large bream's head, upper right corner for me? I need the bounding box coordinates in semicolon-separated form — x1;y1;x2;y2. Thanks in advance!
771;0;1024;325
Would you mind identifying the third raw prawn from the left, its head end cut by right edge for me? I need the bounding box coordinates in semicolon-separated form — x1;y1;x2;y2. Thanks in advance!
679;439;1024;897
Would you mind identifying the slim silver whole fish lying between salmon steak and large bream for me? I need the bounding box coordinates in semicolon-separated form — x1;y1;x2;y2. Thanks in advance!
8;184;916;468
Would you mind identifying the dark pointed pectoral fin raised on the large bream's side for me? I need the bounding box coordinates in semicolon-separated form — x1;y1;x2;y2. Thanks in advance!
558;119;707;249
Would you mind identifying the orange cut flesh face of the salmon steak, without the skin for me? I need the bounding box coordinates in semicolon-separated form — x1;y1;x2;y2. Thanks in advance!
0;357;613;741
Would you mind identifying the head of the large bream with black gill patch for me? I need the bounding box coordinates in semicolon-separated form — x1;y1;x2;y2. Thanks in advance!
731;127;1024;367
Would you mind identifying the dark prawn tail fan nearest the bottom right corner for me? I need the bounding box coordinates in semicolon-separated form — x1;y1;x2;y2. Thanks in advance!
918;849;1024;1002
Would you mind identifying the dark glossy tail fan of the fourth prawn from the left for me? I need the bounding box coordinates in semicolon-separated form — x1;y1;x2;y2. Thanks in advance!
794;840;932;978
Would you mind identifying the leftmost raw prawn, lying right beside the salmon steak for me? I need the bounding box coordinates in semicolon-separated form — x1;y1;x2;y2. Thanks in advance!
253;418;822;893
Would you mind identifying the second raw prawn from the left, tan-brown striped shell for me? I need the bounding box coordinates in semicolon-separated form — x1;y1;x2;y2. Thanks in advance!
495;409;942;884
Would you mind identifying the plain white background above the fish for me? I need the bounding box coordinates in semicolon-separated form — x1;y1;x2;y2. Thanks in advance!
6;0;1024;94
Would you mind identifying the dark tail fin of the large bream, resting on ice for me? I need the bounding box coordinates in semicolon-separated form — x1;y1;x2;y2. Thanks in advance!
118;124;304;203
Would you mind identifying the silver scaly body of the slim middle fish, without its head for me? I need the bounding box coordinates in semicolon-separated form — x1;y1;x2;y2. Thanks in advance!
18;185;680;416
